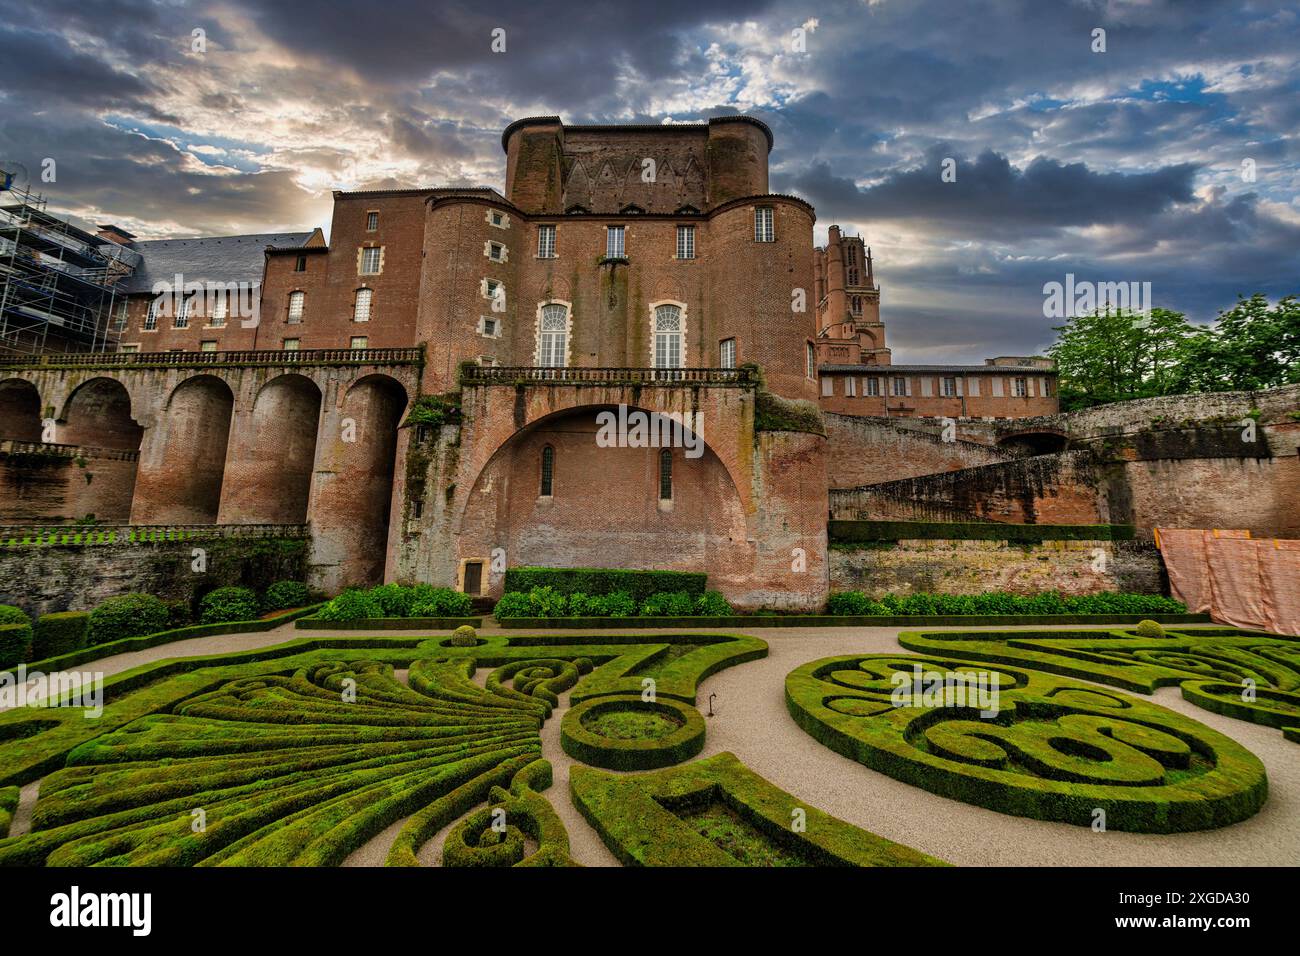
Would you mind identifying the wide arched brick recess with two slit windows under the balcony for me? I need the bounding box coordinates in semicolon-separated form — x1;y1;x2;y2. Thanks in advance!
458;406;754;593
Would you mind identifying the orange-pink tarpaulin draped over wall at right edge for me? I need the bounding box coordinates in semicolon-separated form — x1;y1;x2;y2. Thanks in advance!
1156;528;1300;636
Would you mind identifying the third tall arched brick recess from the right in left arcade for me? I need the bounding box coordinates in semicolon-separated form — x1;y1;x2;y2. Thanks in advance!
131;375;234;524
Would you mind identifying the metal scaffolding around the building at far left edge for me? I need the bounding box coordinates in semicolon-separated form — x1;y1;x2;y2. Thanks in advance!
0;169;140;356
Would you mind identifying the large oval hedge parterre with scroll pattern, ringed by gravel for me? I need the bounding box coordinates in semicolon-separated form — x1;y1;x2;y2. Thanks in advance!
785;654;1268;832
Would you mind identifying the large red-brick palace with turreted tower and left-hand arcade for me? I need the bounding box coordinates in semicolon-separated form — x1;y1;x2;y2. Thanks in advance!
0;116;1081;607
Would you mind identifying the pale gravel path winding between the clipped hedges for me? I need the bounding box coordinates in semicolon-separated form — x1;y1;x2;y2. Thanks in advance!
12;624;1300;866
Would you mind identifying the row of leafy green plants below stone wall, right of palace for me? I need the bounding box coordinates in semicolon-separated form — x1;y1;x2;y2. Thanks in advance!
826;591;1187;617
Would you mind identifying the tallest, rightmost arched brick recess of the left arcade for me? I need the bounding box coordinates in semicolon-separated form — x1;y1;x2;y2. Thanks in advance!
308;375;407;584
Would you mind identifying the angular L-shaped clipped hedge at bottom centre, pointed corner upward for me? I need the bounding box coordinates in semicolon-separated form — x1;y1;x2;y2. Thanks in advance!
569;753;946;866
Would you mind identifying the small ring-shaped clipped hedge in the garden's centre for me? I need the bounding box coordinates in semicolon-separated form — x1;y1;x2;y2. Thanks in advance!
560;695;705;770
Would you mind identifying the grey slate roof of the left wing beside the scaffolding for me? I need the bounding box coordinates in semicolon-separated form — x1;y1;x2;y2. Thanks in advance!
118;232;312;294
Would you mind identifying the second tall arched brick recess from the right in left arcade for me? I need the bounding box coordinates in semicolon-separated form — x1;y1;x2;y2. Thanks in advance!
218;375;321;524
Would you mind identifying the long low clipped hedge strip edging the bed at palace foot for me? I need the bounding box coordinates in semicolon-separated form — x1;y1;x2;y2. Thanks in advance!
491;614;1214;631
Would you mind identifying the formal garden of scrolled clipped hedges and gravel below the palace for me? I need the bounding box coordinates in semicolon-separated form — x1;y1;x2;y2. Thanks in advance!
0;568;1300;866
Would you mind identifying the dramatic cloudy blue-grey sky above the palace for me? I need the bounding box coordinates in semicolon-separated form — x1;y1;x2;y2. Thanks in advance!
0;0;1300;362
